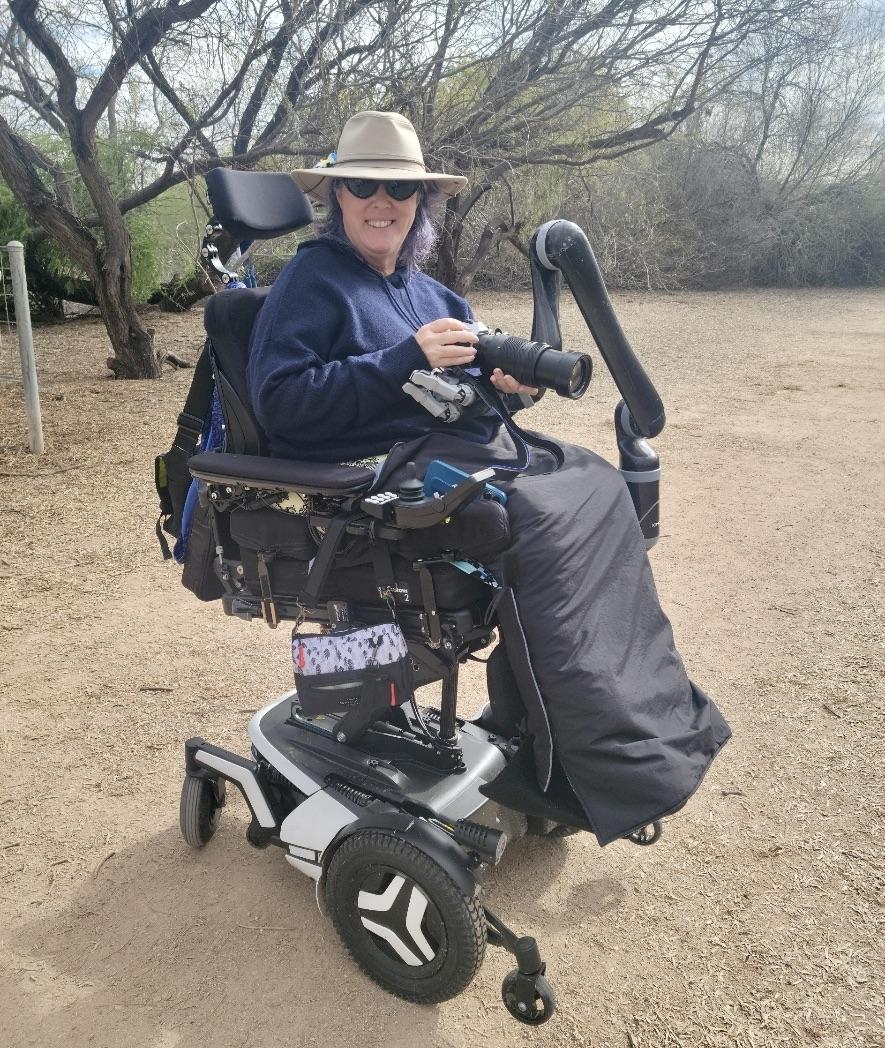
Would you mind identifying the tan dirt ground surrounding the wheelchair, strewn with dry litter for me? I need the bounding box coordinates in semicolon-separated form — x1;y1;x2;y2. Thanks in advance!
0;291;885;1048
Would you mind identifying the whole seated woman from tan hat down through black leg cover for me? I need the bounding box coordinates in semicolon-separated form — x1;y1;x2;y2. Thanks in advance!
249;112;730;844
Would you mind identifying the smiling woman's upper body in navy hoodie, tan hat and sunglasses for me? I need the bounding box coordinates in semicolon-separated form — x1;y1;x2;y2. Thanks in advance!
249;112;537;462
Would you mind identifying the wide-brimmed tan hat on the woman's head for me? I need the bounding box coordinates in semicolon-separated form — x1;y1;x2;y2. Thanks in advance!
292;110;467;200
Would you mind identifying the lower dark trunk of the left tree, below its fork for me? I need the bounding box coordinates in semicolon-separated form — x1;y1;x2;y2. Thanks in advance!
90;243;160;378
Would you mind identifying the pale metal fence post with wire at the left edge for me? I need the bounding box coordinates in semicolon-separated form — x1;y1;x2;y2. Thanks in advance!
0;240;43;455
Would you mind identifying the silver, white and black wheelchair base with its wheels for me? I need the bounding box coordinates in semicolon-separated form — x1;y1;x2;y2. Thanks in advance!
180;692;555;1024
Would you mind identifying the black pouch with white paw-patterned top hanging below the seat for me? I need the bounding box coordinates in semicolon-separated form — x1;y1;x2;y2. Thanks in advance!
292;623;414;743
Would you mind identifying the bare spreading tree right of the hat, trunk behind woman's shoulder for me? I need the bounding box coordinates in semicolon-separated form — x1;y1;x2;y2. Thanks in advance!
384;0;818;290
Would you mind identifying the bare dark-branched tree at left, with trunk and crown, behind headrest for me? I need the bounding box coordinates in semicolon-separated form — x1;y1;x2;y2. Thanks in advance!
0;0;381;377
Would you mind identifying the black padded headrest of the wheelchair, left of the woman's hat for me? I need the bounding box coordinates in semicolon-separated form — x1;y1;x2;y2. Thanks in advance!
206;168;314;240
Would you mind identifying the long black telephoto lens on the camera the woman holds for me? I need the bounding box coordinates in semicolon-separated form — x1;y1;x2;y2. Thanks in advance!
470;324;592;400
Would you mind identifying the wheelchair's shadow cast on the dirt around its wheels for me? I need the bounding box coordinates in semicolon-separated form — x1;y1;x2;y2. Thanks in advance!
4;816;567;1048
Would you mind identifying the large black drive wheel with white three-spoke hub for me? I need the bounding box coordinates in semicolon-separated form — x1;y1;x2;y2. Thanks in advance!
326;831;485;1004
